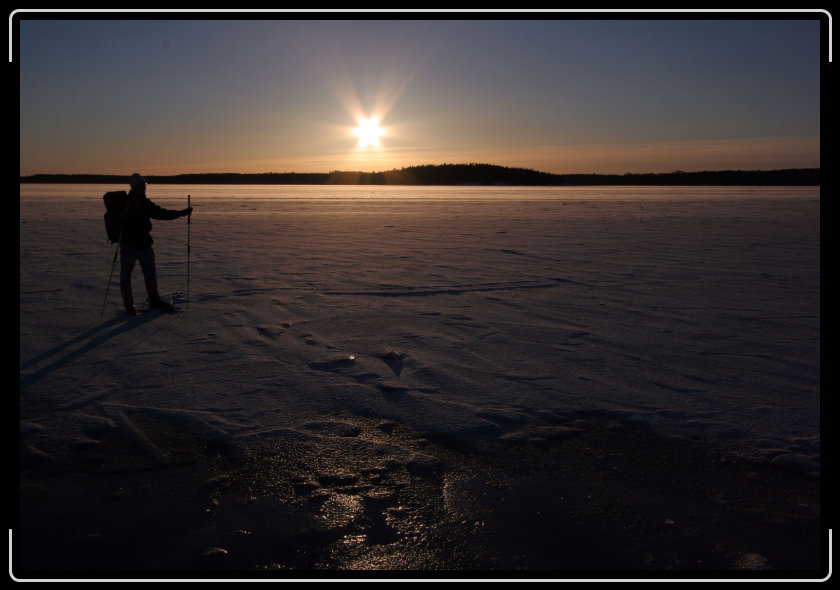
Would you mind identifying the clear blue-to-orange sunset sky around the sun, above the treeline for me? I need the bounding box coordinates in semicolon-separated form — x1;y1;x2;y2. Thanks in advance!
16;13;828;175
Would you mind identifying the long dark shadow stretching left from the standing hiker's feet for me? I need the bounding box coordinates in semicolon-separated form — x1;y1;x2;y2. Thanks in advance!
20;313;160;391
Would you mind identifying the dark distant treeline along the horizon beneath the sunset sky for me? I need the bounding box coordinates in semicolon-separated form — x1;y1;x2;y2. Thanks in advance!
20;164;820;186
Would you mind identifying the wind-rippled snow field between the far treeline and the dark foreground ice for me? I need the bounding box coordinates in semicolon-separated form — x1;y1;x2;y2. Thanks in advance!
20;184;820;472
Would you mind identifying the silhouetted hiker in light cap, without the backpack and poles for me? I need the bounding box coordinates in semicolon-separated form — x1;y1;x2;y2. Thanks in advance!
120;172;192;315
